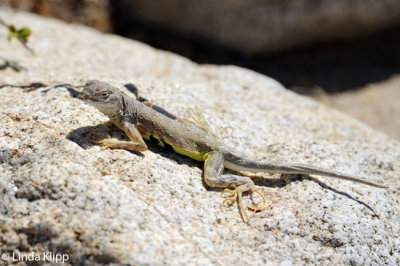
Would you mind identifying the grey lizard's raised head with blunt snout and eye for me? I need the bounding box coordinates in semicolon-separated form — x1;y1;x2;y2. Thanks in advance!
78;80;123;115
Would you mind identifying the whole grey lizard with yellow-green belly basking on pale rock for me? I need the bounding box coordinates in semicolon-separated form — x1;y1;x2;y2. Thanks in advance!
78;80;386;222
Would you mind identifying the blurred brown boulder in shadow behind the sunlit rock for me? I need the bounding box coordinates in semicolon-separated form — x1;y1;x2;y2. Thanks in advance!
115;0;400;53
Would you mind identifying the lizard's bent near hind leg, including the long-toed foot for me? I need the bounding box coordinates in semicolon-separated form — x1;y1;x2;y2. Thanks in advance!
204;151;266;222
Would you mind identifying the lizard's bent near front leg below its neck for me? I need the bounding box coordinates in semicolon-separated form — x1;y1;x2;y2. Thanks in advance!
94;121;147;152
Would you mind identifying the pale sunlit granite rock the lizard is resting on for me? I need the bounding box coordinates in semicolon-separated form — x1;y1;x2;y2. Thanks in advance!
0;10;400;265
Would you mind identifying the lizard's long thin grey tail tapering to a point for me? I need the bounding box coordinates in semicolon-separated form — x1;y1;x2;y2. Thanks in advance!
224;153;387;188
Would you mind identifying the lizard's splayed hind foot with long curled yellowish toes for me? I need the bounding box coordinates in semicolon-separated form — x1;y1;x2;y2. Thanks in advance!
221;184;267;223
